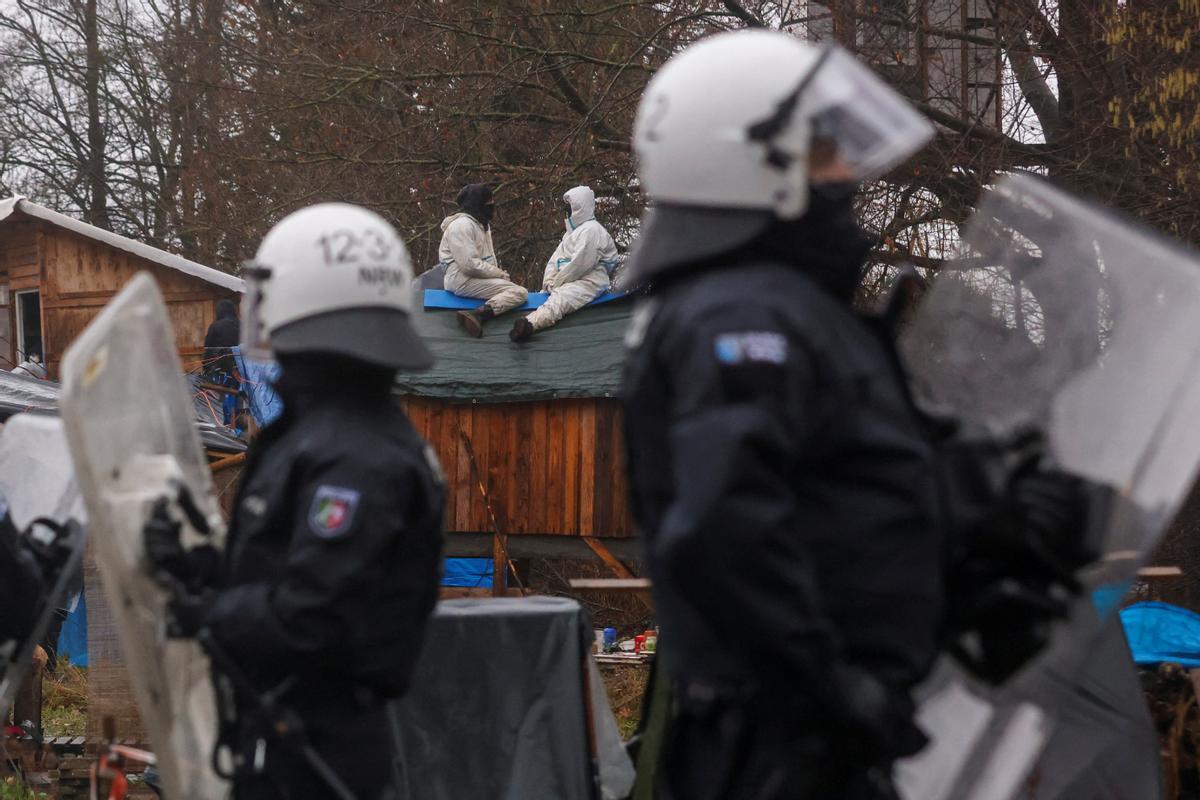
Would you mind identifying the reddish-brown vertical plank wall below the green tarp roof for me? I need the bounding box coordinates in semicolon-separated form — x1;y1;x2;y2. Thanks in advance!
403;397;634;536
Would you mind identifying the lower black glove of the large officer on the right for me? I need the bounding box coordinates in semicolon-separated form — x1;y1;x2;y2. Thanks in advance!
830;663;929;764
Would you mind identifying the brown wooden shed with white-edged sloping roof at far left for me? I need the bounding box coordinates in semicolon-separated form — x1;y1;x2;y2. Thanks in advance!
0;197;242;378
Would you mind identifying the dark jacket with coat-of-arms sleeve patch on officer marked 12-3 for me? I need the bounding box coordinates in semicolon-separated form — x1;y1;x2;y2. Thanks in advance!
205;395;444;700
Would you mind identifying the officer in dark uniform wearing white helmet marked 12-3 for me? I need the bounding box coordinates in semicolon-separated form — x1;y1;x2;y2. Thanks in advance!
146;204;443;799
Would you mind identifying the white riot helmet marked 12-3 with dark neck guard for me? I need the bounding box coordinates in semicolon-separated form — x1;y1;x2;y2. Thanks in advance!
242;203;433;369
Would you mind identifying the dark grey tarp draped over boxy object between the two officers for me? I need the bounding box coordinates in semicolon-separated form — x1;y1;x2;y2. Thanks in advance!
396;597;632;800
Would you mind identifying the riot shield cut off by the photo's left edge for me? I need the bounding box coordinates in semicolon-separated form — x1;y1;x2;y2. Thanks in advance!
0;414;84;720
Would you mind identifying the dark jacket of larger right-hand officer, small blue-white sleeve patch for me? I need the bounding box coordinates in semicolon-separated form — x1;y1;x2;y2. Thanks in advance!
625;260;944;710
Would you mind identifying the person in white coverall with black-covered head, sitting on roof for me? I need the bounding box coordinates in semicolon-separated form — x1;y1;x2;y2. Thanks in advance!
438;184;529;338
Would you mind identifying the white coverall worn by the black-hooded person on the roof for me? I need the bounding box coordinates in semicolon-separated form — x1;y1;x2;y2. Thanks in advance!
438;211;529;315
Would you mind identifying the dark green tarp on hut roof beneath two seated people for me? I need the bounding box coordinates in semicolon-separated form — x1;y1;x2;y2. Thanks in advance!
398;299;634;403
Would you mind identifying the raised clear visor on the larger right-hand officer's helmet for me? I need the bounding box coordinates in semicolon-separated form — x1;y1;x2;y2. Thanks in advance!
799;46;934;181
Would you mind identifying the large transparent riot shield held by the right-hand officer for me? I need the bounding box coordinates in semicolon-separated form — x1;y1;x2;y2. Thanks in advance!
899;176;1200;800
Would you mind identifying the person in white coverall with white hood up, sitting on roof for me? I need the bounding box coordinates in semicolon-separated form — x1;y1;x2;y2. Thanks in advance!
509;186;617;342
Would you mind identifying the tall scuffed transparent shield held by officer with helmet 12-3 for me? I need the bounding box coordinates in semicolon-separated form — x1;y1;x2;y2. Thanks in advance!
60;272;228;800
